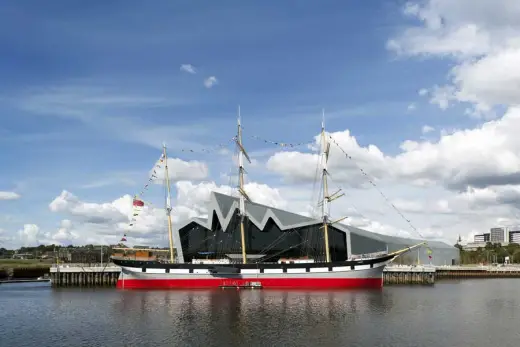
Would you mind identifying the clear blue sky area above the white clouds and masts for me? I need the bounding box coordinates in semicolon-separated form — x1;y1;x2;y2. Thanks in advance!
0;0;500;247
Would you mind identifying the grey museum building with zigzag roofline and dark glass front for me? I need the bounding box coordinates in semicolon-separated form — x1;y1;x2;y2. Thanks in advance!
179;192;459;265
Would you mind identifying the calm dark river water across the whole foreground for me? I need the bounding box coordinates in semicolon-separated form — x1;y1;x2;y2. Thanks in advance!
0;279;520;347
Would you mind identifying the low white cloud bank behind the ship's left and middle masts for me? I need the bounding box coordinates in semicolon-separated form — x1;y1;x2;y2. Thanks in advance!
35;181;287;245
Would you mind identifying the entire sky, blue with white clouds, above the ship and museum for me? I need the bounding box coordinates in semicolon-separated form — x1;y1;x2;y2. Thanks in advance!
0;0;520;248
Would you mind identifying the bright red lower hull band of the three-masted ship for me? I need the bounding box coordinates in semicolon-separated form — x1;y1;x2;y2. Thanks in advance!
117;278;383;289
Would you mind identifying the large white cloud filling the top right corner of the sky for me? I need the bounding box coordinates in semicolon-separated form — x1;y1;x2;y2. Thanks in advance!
387;0;520;118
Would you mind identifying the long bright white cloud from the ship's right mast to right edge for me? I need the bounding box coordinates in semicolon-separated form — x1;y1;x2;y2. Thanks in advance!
267;108;520;190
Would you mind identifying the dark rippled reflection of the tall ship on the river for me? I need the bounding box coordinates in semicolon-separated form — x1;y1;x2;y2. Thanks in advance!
108;290;393;345
